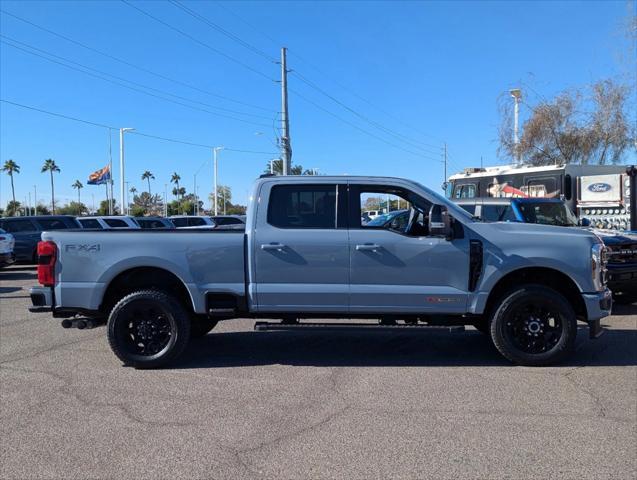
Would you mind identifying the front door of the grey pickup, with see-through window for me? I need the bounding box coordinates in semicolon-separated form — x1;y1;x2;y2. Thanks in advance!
349;184;469;314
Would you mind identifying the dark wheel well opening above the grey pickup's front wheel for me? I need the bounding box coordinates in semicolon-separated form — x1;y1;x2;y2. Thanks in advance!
484;267;587;319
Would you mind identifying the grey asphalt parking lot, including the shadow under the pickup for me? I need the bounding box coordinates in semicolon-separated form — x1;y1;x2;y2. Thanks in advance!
0;267;637;479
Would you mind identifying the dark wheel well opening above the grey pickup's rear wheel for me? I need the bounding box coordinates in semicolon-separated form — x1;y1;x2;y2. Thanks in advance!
99;267;194;315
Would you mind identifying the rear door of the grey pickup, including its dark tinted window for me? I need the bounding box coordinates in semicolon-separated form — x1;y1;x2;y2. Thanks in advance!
251;180;349;313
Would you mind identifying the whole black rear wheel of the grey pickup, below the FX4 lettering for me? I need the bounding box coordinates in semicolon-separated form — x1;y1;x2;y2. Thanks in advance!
108;290;190;368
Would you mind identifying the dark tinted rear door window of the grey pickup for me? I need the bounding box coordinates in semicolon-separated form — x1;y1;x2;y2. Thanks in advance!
268;185;336;229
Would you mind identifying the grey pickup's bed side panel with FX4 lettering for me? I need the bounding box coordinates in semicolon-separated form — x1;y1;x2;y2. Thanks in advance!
42;230;245;313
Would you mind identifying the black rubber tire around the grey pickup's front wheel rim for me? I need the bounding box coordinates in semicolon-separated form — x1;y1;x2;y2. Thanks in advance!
490;284;577;366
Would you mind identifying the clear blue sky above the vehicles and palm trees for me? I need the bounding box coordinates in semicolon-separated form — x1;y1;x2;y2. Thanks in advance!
0;0;635;209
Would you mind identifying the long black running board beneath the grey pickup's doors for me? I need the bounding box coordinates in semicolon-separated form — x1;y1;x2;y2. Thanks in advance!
254;322;464;332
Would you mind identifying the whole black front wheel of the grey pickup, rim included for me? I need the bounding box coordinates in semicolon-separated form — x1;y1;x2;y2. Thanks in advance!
490;285;577;366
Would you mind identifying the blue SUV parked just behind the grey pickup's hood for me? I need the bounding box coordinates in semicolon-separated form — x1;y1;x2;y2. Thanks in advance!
456;197;637;301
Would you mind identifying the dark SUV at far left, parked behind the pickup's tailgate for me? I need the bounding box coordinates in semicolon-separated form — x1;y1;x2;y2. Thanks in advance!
0;215;80;263
